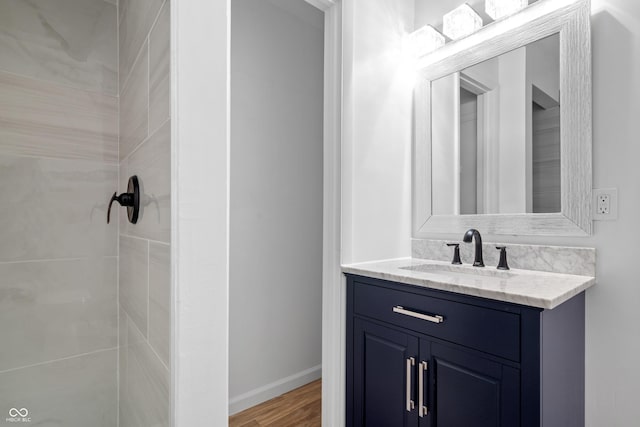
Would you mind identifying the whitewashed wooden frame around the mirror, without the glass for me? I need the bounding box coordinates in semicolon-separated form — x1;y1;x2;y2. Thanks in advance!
412;0;592;238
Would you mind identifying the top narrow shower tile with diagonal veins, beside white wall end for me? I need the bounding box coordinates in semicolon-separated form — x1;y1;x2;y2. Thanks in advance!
149;2;171;133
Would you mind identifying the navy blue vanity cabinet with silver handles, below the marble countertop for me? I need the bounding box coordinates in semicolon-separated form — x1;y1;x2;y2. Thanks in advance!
346;275;584;427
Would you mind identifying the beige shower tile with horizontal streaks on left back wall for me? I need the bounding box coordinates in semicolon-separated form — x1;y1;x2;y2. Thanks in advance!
0;72;118;162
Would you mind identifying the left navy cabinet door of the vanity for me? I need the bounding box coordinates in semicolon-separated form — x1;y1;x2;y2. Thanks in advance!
353;318;419;427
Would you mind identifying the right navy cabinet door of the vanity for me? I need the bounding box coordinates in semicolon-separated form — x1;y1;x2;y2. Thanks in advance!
420;340;520;427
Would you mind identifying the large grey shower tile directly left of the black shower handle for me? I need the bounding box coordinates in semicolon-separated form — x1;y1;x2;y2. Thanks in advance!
0;155;118;262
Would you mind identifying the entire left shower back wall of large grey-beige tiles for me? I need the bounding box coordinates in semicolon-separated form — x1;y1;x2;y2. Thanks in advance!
0;0;118;427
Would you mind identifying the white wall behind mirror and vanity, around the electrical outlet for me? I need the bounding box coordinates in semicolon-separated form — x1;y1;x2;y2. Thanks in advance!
416;0;640;427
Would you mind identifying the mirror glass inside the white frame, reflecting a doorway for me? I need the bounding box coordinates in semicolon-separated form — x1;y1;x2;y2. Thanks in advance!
431;34;561;215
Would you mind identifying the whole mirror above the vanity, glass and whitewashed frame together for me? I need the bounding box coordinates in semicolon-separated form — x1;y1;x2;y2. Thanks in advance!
413;0;592;237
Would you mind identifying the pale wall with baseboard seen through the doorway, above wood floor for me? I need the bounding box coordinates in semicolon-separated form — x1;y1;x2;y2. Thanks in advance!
229;0;324;413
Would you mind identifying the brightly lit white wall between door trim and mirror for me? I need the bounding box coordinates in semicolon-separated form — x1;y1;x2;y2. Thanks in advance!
342;0;415;262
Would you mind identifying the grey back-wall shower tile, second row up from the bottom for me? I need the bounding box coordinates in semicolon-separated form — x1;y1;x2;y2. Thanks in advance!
0;257;117;371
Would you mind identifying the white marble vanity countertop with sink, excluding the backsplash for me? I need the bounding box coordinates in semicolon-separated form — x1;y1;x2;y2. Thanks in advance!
342;258;596;309
